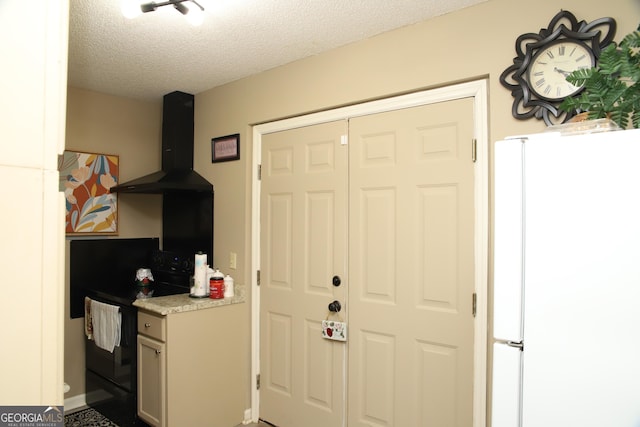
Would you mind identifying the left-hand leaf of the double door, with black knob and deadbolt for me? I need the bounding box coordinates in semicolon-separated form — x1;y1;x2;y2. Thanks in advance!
260;121;347;427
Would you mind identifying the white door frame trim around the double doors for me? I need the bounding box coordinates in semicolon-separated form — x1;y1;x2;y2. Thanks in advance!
251;79;489;427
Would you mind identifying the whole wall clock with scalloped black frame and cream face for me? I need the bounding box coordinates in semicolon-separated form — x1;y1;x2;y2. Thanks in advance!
500;10;616;126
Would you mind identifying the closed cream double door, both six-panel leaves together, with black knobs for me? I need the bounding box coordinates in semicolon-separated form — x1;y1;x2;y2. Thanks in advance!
259;98;475;427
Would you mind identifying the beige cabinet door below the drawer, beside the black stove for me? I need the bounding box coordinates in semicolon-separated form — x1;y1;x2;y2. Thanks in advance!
138;335;167;427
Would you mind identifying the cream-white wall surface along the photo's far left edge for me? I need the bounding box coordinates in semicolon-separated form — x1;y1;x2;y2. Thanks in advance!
0;0;69;405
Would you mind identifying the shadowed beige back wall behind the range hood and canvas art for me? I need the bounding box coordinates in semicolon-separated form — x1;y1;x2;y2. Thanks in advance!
64;88;162;398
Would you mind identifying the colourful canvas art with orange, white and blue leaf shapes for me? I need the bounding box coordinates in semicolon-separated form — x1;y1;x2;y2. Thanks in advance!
58;151;118;234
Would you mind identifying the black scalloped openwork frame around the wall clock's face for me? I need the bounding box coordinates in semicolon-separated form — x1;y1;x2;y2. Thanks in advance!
500;10;616;126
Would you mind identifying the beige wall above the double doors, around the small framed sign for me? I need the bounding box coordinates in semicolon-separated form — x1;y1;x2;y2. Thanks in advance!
194;0;640;283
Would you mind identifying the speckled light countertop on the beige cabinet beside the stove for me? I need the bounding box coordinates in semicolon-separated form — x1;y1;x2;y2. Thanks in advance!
133;285;245;316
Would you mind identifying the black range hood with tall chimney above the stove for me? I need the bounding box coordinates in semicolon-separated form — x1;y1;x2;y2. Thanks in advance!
111;91;213;194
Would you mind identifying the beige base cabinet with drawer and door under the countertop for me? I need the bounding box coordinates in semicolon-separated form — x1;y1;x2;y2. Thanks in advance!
138;305;248;427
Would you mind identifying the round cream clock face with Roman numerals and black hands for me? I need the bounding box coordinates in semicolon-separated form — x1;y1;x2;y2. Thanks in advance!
527;39;595;101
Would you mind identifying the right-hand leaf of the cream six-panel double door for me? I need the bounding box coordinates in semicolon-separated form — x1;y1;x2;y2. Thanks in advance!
348;98;474;427
